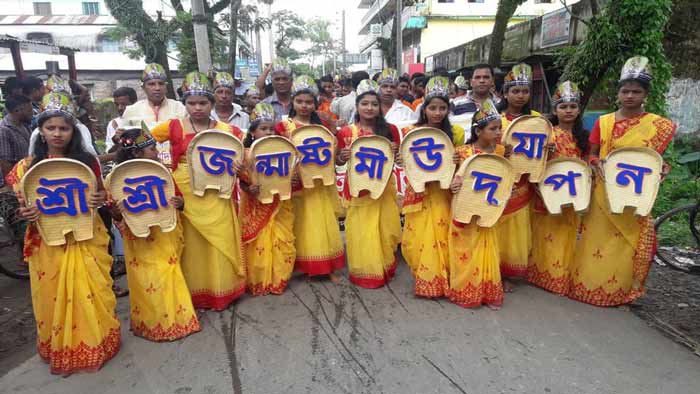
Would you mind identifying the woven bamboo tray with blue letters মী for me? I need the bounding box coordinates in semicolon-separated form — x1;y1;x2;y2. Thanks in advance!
348;135;394;200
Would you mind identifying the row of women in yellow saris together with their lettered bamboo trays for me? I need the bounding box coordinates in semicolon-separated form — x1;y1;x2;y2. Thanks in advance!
5;53;675;374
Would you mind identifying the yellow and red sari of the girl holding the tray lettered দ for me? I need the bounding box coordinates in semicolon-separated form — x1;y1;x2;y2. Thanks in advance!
447;145;505;308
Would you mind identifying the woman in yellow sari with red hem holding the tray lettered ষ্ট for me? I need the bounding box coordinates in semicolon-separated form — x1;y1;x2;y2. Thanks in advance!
275;75;345;282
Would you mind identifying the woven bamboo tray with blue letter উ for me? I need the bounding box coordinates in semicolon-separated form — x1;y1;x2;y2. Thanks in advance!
400;127;456;193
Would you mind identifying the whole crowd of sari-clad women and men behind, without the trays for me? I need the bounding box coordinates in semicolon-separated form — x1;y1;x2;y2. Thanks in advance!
0;57;675;373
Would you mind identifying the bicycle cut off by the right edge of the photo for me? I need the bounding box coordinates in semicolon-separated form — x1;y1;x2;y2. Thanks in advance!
654;200;700;275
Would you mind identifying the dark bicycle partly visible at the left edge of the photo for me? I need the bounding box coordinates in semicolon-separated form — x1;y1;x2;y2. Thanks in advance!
0;192;29;280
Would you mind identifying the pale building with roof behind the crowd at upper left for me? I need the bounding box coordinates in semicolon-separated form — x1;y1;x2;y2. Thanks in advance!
0;0;189;98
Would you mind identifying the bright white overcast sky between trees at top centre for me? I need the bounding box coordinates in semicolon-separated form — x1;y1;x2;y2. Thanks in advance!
261;0;367;63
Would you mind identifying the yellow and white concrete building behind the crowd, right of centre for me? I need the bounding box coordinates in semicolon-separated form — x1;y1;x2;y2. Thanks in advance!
358;0;577;72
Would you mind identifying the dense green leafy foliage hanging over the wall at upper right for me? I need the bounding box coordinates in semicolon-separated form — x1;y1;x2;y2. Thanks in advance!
558;0;672;115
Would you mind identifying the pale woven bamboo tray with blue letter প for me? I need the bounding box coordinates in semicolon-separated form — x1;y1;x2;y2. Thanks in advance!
538;157;591;215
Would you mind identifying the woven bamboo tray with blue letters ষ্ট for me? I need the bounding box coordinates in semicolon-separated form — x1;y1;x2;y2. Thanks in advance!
292;125;336;189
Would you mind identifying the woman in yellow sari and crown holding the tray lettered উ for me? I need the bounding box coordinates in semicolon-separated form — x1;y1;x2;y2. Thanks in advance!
401;77;464;298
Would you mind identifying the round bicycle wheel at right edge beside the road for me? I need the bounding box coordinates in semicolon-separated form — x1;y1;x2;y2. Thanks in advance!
654;203;700;275
